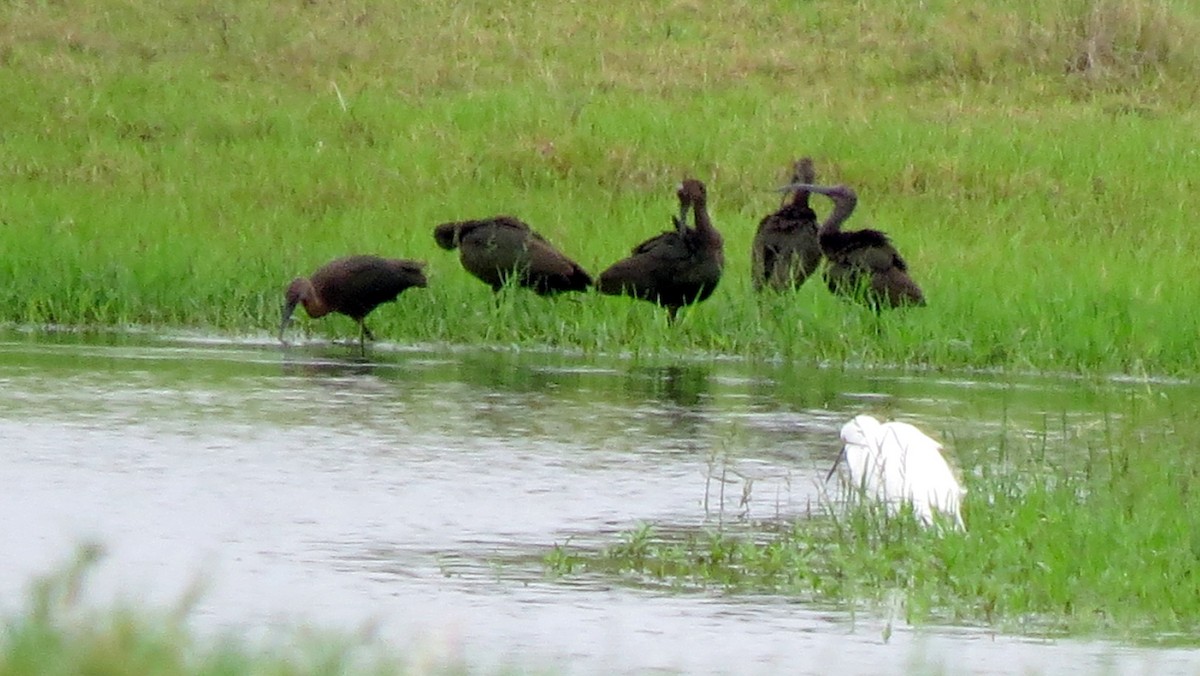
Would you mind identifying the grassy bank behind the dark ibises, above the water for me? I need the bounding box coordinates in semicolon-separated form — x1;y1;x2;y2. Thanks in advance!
0;0;1200;373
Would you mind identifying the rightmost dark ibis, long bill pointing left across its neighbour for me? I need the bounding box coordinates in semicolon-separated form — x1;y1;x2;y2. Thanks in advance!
781;184;925;310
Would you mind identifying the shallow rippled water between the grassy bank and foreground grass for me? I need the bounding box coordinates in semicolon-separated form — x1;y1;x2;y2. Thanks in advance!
0;334;1200;674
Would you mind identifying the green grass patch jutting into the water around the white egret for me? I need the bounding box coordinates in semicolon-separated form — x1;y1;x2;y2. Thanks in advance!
546;406;1200;645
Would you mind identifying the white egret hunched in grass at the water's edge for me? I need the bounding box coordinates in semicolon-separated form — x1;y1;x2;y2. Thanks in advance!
826;415;966;528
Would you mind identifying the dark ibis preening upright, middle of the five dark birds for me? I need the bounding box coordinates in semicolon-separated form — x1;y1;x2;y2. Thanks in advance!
596;179;725;323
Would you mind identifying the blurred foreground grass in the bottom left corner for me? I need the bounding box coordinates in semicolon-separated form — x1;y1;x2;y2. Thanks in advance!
0;546;472;676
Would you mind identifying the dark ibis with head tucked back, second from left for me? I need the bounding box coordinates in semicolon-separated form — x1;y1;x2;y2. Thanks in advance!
433;216;592;295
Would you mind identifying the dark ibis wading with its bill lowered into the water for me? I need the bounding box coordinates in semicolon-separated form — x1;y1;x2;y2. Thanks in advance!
280;256;426;349
